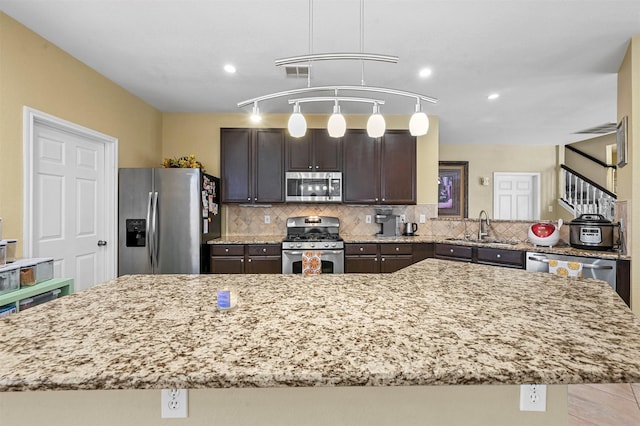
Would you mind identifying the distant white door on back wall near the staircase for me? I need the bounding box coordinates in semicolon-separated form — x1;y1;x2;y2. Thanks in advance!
493;172;540;220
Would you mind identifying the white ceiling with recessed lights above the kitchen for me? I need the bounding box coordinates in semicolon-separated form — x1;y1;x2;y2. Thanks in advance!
0;0;640;144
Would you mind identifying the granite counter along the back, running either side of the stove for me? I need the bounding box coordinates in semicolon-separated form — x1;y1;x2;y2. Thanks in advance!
207;235;631;259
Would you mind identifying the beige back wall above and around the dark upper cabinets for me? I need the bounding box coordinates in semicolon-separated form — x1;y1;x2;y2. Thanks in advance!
162;113;438;204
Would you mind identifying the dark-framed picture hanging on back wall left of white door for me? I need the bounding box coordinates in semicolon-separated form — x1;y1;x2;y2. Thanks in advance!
438;161;469;218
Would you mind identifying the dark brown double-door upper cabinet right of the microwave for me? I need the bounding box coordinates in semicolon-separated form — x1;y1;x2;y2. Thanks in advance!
343;130;416;204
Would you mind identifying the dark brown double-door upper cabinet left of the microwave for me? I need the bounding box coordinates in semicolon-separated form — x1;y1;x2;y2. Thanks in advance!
220;129;284;203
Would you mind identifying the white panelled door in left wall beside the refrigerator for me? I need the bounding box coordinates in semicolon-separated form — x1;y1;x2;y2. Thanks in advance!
25;108;117;291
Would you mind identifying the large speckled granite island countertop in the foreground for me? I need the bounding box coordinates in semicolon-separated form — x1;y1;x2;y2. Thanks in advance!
0;259;640;391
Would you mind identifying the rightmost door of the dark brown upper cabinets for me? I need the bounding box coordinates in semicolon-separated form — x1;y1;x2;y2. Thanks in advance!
380;130;416;204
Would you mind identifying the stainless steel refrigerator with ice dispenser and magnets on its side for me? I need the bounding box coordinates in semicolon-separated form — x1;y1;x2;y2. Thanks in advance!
118;168;220;276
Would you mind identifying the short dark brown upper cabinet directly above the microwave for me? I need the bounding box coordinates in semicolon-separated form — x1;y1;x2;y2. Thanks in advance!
286;129;342;172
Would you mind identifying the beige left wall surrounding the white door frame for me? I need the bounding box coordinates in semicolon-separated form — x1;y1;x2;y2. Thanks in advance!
0;12;162;251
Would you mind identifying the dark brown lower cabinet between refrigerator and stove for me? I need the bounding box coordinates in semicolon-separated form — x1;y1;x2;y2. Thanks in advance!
210;244;282;274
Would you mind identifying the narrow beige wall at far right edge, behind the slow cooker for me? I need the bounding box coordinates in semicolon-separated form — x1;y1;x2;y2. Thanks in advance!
617;36;640;314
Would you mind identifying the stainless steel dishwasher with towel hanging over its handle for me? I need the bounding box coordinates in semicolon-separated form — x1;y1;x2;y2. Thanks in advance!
527;252;616;290
